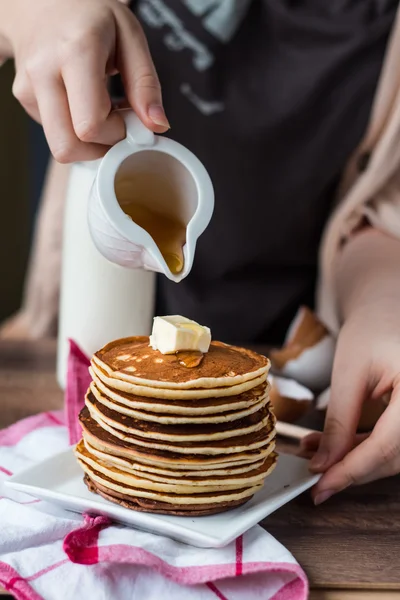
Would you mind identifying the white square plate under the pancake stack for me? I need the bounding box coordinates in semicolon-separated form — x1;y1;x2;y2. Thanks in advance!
6;448;319;548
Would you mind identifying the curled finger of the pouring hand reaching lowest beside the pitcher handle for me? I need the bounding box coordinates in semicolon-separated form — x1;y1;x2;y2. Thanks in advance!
34;77;108;163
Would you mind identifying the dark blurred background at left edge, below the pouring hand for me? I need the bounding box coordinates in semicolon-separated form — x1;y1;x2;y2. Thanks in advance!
0;61;49;322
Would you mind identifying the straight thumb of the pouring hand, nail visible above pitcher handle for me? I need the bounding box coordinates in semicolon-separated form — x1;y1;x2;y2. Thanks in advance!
116;11;169;133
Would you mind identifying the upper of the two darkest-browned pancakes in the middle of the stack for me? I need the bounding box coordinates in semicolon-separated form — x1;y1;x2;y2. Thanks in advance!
85;392;270;442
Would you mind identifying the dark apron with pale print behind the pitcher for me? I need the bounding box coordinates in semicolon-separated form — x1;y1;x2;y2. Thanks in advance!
122;0;398;343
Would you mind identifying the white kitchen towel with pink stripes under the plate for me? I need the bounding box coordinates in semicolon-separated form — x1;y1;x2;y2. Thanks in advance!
0;344;308;600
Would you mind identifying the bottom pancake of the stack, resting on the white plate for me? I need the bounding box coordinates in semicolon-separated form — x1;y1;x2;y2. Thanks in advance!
84;474;252;517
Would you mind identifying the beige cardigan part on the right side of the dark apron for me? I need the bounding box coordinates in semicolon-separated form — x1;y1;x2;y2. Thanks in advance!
317;7;400;332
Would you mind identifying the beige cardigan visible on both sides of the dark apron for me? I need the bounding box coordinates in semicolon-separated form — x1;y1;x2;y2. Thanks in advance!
0;8;400;338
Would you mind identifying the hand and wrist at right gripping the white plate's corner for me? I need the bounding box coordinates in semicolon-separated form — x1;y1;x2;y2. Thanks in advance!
304;228;400;503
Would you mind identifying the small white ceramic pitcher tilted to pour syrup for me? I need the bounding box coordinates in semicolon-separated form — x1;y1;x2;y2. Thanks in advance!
89;110;214;282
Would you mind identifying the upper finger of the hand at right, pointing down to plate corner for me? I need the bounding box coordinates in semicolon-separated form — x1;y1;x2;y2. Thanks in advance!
310;347;367;473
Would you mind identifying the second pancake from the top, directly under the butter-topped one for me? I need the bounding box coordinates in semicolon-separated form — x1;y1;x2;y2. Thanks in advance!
89;361;267;400
